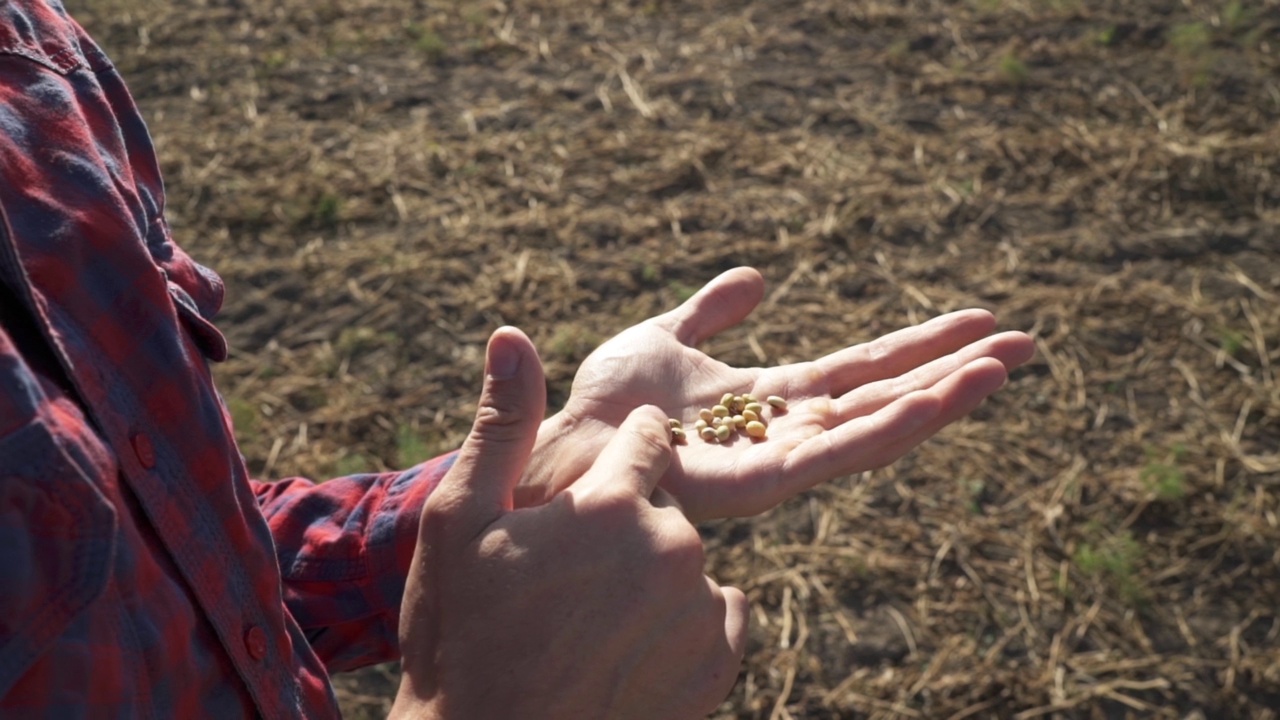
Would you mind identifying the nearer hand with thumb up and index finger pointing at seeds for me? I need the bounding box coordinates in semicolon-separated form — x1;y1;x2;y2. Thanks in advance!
392;329;746;720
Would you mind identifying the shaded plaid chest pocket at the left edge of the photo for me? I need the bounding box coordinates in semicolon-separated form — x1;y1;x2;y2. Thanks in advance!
0;417;116;696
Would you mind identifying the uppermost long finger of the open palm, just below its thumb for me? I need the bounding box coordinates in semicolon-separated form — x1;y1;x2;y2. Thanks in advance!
815;310;996;397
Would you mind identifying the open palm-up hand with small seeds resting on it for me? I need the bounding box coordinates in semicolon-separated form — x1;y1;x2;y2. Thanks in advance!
518;268;1034;520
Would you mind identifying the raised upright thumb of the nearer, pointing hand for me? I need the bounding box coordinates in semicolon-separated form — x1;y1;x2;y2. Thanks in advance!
430;327;547;542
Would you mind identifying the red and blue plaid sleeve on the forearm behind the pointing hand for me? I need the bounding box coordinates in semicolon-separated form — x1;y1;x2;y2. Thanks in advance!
251;454;454;673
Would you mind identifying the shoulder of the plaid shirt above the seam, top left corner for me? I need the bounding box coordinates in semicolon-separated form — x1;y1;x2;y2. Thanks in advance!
0;0;111;74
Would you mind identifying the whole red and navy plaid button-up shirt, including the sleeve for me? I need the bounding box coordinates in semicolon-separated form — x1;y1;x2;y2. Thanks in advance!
0;0;449;719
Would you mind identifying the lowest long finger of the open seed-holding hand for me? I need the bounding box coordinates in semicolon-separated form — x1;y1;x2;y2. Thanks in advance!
778;357;1007;497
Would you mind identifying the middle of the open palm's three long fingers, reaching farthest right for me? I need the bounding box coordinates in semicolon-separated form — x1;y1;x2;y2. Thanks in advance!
832;332;1036;425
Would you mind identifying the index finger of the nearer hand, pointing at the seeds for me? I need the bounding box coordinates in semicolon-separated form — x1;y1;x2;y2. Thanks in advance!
567;405;672;500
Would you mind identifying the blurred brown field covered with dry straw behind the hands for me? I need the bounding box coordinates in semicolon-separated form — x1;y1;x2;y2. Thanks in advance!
77;0;1280;720
